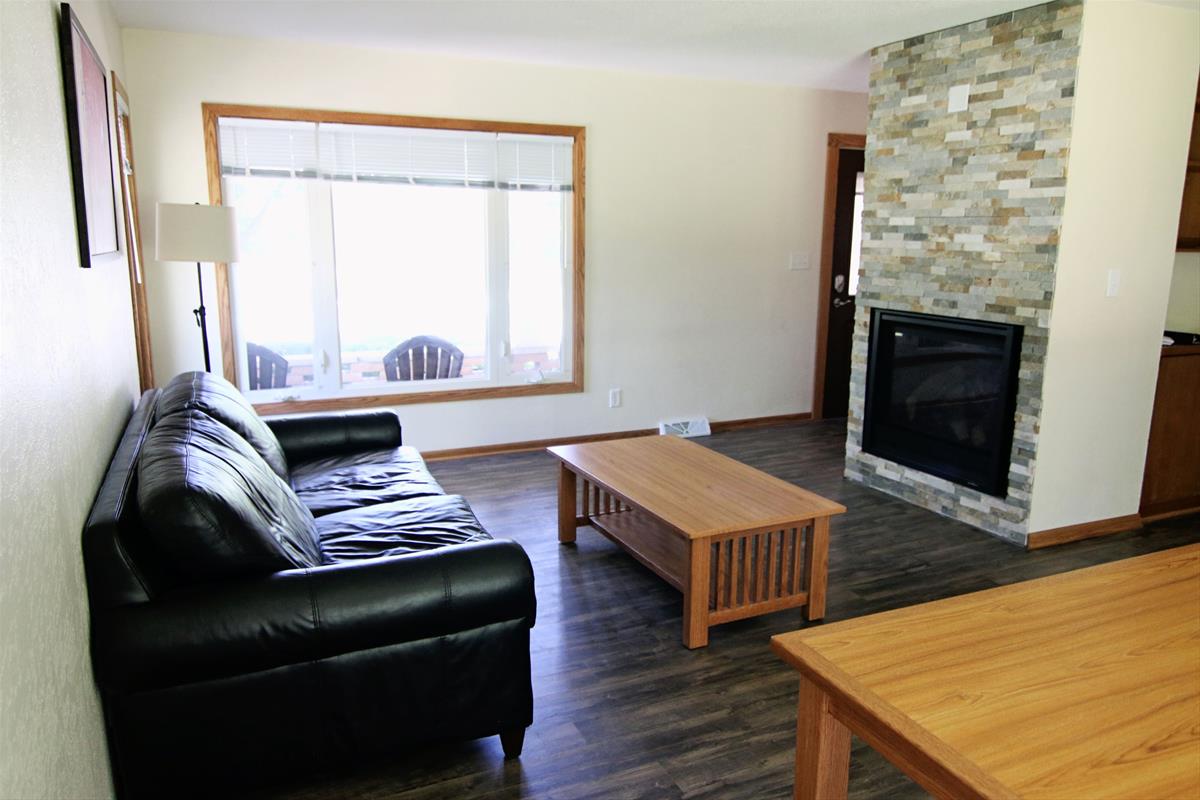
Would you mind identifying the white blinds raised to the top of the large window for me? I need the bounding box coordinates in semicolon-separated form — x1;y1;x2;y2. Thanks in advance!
218;118;574;192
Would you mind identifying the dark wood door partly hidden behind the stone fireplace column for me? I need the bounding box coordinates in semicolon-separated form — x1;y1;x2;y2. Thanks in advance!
821;149;863;419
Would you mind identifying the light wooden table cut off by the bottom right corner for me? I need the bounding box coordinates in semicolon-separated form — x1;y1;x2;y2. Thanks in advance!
772;545;1200;800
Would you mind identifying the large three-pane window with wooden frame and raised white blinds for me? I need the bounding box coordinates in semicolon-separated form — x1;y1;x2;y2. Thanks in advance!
204;104;583;411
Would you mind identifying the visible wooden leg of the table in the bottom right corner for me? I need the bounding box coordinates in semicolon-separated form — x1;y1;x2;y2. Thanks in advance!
793;675;850;800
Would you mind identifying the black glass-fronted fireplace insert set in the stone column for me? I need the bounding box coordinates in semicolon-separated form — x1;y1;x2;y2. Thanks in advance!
863;308;1022;497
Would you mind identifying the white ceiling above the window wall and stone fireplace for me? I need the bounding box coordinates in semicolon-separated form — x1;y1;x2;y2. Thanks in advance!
113;0;1060;91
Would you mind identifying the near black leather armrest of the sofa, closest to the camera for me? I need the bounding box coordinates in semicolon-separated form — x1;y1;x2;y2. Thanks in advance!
92;540;536;692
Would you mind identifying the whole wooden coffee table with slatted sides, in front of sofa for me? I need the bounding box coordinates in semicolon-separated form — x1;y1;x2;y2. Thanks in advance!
550;437;846;648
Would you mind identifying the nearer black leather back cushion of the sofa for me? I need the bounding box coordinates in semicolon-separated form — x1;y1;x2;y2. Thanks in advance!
138;409;322;579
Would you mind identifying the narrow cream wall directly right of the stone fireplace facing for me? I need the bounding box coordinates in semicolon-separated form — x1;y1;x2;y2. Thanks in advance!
1030;1;1200;531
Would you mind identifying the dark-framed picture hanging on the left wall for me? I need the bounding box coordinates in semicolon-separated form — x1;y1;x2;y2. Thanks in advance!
59;2;119;269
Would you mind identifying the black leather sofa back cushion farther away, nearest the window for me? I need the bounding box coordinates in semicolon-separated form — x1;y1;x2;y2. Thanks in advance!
157;372;288;480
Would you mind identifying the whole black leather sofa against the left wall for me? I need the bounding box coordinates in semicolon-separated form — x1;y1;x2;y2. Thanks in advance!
83;373;535;796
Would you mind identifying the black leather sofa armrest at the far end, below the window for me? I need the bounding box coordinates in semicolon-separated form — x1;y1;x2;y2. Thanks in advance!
263;410;402;463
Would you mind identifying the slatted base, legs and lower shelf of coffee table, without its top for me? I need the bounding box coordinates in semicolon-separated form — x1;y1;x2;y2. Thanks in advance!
559;467;829;649
